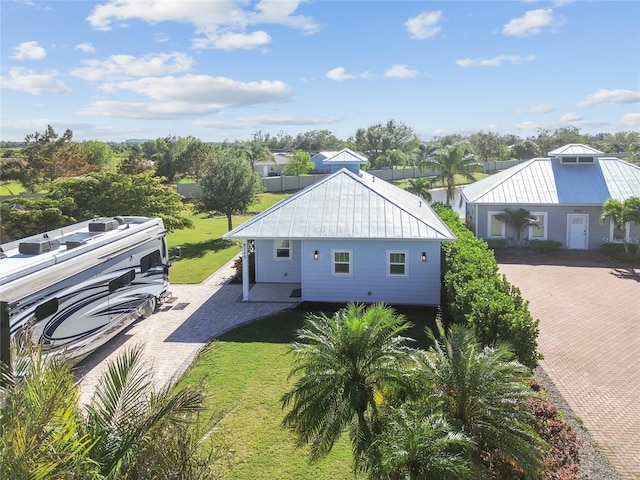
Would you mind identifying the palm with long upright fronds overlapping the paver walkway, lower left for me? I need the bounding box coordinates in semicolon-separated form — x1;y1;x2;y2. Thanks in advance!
84;346;211;479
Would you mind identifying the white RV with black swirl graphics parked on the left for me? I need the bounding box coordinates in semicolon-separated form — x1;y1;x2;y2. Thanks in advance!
0;217;178;364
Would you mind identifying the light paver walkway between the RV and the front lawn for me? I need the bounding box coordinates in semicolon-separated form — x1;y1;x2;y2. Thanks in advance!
76;262;296;403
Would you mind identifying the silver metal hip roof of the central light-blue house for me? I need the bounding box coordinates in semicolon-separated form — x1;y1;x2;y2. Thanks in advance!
223;169;456;244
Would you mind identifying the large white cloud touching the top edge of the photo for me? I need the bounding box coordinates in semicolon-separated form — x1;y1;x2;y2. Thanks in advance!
87;0;320;50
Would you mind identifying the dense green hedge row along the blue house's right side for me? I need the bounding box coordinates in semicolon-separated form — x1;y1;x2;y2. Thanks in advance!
435;205;540;368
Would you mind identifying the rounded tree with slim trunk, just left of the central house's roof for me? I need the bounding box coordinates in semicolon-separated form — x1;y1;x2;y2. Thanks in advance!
195;150;262;230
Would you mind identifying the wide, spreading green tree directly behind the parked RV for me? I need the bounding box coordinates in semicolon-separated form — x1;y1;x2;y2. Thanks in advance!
47;172;192;230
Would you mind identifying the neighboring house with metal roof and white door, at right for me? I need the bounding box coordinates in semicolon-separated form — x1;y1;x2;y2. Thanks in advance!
461;144;640;250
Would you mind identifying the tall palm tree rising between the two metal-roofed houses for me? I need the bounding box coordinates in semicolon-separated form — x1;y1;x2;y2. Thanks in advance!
418;142;482;205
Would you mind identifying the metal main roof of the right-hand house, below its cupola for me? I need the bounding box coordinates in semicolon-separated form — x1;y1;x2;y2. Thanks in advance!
461;157;640;205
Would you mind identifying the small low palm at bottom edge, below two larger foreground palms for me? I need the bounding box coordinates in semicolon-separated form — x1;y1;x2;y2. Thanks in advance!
369;405;474;480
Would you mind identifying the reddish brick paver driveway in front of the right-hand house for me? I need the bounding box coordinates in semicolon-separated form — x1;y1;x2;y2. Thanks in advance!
496;251;640;479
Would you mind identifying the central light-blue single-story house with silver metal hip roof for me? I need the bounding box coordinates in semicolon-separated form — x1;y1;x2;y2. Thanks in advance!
223;154;455;305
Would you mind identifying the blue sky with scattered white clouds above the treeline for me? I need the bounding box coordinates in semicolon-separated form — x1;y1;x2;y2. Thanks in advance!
0;0;640;141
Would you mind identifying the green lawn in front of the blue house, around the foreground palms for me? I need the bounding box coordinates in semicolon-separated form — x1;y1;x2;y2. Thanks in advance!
183;309;435;480
